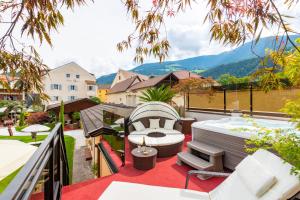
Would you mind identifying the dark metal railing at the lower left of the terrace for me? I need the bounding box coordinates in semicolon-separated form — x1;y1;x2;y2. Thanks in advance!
0;123;69;200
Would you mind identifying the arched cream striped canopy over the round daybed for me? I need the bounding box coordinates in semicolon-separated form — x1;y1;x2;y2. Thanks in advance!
129;101;180;122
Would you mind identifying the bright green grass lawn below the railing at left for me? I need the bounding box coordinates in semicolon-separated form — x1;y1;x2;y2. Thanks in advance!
0;135;75;193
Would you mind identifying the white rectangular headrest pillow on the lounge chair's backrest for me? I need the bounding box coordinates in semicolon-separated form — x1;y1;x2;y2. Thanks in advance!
236;156;276;198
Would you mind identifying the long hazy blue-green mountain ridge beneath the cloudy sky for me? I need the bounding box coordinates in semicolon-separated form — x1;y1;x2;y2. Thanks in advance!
97;35;300;84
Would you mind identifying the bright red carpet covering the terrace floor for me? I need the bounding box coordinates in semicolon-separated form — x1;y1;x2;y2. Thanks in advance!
62;136;224;200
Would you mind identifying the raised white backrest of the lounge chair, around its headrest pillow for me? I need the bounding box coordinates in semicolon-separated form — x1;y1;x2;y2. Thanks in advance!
209;149;300;200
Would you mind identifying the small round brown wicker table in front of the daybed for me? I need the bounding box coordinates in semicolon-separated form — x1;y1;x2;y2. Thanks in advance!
131;147;157;170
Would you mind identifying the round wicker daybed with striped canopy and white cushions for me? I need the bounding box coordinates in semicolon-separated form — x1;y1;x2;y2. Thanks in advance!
128;101;185;157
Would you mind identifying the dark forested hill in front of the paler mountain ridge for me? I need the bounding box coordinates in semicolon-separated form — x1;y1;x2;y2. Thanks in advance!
200;58;260;79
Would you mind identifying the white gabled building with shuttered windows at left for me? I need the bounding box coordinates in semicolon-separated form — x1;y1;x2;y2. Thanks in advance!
44;62;97;104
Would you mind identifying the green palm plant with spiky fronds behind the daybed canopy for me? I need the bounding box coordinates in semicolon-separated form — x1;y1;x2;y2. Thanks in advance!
139;85;175;103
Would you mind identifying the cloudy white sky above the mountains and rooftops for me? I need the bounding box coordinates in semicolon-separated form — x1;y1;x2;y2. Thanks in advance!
25;0;300;77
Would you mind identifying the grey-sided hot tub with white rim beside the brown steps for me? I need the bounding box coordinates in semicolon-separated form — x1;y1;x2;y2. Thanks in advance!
192;117;300;170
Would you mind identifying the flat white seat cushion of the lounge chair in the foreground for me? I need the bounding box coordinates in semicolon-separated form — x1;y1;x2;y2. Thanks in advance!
99;181;210;200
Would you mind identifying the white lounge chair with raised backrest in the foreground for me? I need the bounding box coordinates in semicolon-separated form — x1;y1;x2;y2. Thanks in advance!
99;150;300;200
